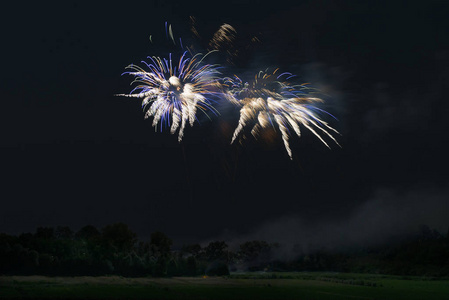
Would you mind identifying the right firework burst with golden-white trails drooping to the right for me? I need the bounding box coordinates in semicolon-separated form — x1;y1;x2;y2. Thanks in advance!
224;69;338;159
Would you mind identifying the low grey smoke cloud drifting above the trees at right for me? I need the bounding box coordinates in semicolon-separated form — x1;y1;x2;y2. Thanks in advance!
214;187;449;256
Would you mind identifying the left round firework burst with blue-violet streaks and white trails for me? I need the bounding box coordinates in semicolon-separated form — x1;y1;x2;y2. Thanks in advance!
118;51;219;142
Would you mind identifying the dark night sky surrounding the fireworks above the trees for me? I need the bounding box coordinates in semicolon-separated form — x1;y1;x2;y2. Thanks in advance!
0;0;449;244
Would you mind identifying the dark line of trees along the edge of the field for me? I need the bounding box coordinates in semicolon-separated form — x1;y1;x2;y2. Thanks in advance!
0;223;449;277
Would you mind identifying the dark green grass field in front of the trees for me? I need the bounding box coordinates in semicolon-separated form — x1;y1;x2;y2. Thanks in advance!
0;273;449;300
